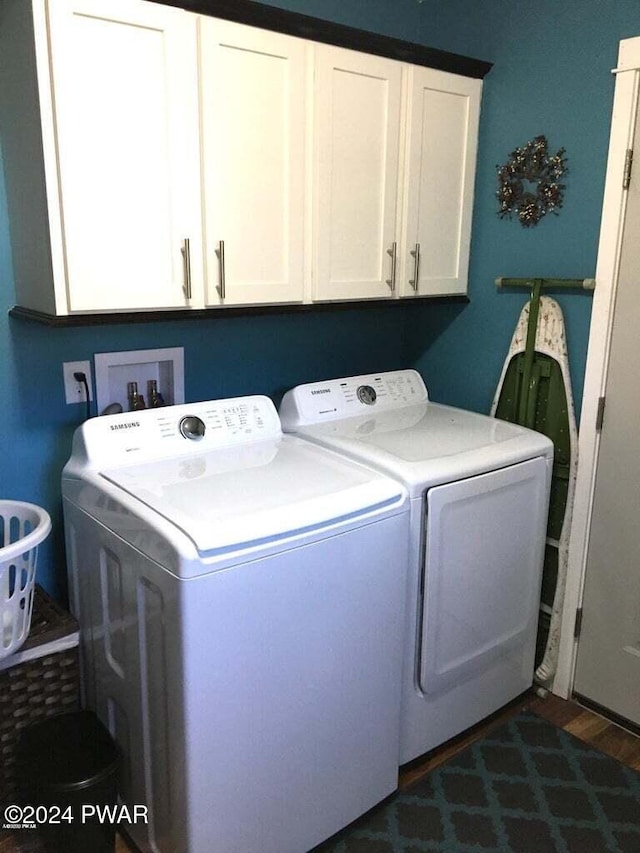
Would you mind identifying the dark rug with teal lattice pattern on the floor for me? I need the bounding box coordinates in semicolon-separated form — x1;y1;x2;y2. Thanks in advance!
313;712;640;853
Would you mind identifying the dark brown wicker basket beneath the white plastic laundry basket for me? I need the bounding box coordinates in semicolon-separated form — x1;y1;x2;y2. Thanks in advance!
0;584;80;803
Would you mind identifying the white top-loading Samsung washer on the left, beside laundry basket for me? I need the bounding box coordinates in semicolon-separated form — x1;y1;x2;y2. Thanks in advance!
62;396;409;853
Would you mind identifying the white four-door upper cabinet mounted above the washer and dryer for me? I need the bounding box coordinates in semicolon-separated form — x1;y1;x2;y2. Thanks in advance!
0;0;482;316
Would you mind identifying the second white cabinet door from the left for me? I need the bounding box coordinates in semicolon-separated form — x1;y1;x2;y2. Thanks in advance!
200;17;307;305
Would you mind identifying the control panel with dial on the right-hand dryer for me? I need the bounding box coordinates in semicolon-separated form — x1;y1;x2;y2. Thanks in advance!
280;370;429;429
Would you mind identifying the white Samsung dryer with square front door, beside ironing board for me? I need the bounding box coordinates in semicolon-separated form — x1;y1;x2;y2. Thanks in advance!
280;370;553;763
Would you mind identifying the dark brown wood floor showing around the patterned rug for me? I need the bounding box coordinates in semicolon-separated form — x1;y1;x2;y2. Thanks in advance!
0;693;640;853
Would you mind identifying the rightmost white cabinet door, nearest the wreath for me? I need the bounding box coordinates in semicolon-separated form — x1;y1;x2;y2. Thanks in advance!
399;66;482;296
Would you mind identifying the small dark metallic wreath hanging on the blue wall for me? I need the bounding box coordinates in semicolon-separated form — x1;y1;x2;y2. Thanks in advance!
496;136;567;228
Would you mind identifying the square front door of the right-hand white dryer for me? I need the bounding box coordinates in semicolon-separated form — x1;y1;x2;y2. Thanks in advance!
418;458;549;694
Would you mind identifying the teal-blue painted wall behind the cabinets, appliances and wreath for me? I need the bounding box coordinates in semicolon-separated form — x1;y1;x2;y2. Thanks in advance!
0;0;640;599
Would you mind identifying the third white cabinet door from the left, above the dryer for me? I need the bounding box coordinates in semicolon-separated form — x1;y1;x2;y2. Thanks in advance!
314;45;402;300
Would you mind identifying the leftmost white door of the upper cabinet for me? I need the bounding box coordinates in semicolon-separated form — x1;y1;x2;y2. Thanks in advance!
49;0;201;311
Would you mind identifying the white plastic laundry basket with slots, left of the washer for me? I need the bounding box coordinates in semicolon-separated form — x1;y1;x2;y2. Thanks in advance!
0;501;51;660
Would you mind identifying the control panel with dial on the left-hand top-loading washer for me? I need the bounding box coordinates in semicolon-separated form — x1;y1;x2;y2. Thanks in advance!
68;396;282;467
